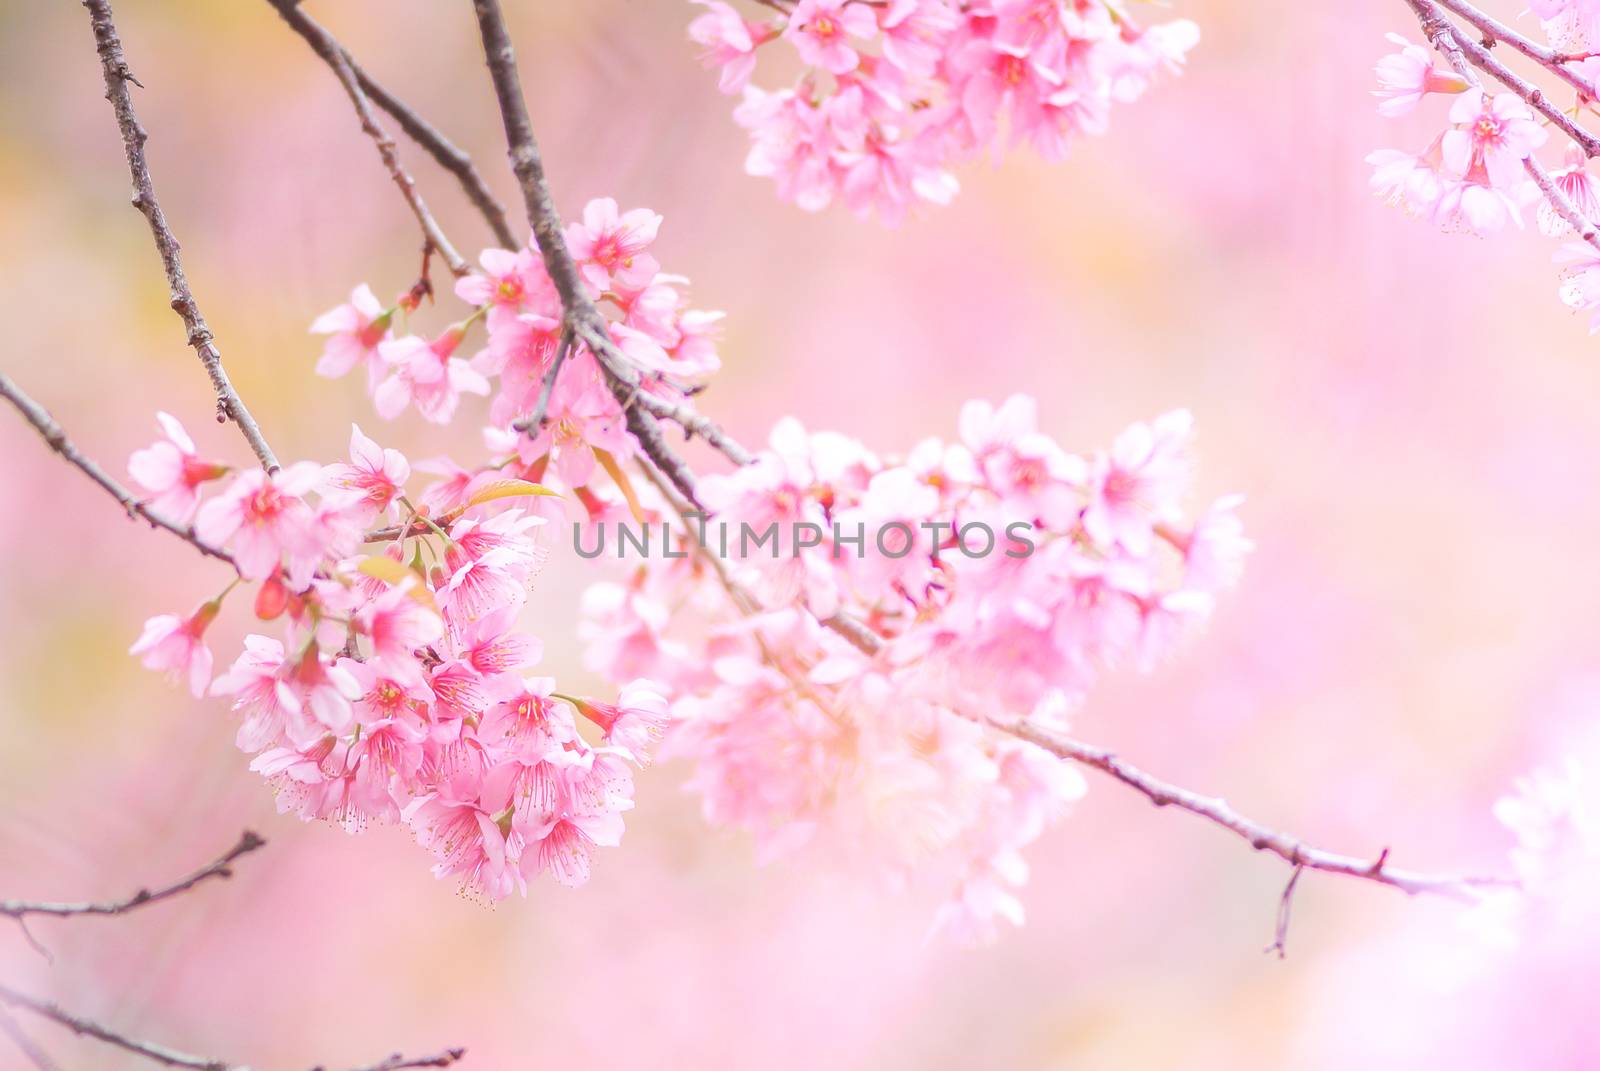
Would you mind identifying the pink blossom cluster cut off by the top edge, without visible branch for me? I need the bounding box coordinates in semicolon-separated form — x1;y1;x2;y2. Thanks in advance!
690;0;1198;223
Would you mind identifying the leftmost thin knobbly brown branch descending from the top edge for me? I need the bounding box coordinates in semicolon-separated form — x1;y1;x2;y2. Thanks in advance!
83;0;278;472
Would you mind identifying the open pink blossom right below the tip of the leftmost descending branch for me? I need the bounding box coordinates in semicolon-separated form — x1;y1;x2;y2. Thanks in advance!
195;461;325;579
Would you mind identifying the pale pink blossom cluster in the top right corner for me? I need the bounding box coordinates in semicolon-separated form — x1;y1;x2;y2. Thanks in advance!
1366;29;1600;331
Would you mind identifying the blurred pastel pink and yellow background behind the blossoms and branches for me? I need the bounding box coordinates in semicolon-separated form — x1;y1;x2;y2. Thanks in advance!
0;0;1600;1069
